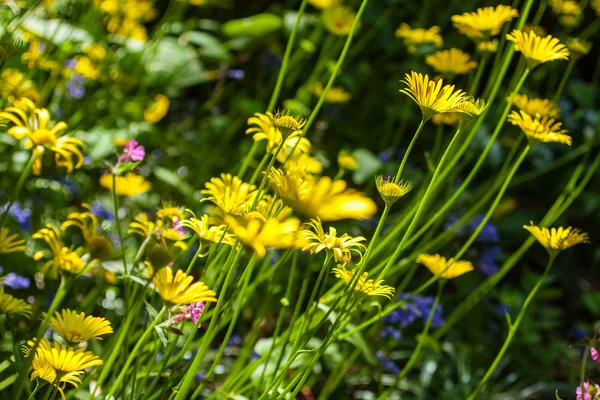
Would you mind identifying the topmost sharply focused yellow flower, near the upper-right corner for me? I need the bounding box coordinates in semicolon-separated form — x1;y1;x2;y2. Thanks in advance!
506;29;570;69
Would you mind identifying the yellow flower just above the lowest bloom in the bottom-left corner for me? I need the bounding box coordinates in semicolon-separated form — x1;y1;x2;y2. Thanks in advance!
50;309;113;345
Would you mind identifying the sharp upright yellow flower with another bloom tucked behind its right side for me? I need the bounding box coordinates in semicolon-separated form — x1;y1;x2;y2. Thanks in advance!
400;71;466;120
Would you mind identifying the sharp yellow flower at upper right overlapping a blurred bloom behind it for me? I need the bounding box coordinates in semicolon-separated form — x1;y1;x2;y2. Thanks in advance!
508;111;572;146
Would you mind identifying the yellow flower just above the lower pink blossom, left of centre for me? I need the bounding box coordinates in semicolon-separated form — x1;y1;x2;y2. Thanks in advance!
152;267;217;305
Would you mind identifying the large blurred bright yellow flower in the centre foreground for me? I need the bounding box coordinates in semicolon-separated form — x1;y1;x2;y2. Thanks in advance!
269;169;377;221
